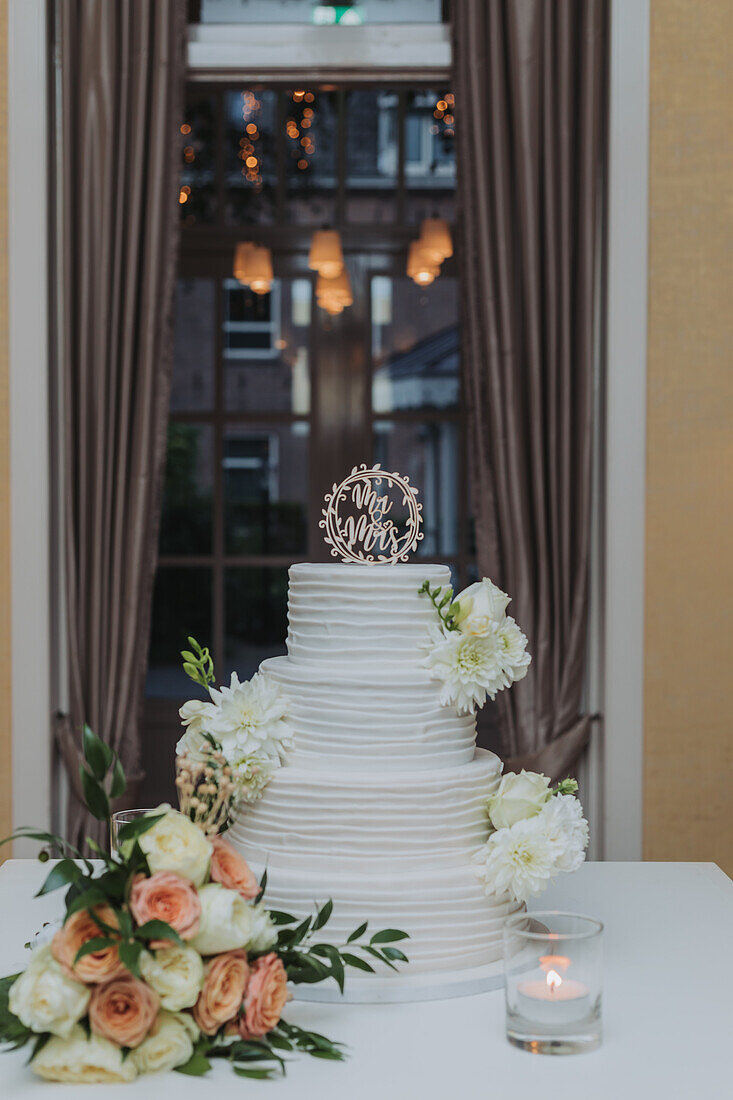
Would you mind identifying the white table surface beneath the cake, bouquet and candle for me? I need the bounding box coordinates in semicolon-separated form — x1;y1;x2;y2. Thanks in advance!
0;860;733;1100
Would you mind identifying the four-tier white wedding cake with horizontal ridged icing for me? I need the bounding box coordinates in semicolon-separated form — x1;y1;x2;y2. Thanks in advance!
229;564;517;1000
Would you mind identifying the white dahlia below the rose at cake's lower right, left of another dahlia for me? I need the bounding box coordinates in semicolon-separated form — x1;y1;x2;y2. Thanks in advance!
473;813;555;901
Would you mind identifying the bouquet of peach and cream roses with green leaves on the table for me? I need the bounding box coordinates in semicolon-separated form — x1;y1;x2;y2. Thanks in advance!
0;727;407;1084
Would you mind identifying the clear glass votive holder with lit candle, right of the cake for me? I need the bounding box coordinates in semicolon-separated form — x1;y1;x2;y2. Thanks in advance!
504;910;603;1054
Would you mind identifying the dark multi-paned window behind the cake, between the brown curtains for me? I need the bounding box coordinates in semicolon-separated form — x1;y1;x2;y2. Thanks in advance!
143;77;464;804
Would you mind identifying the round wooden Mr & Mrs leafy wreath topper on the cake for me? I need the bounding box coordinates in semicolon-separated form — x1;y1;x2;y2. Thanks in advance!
318;462;424;565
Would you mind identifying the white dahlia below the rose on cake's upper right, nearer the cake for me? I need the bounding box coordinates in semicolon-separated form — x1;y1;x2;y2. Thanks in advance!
424;628;505;714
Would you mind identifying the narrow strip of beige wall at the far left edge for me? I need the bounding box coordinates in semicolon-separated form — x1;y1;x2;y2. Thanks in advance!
0;0;12;860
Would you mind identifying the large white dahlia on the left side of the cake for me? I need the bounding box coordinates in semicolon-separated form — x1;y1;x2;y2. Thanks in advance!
209;672;292;767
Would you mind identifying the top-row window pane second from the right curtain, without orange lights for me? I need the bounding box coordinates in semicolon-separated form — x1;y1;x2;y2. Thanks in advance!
347;90;398;224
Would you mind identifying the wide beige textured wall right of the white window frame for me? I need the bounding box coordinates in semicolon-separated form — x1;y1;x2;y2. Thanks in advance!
644;0;733;873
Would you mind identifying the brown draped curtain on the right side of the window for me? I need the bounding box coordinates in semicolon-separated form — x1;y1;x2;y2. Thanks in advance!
453;0;608;777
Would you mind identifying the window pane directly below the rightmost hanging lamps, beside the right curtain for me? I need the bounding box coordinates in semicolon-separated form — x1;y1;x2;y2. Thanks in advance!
372;275;460;413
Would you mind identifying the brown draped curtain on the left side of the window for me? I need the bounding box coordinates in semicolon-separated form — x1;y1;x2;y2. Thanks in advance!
56;0;186;844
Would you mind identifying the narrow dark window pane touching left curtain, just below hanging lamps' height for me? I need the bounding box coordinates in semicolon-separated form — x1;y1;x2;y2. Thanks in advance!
171;278;217;413
